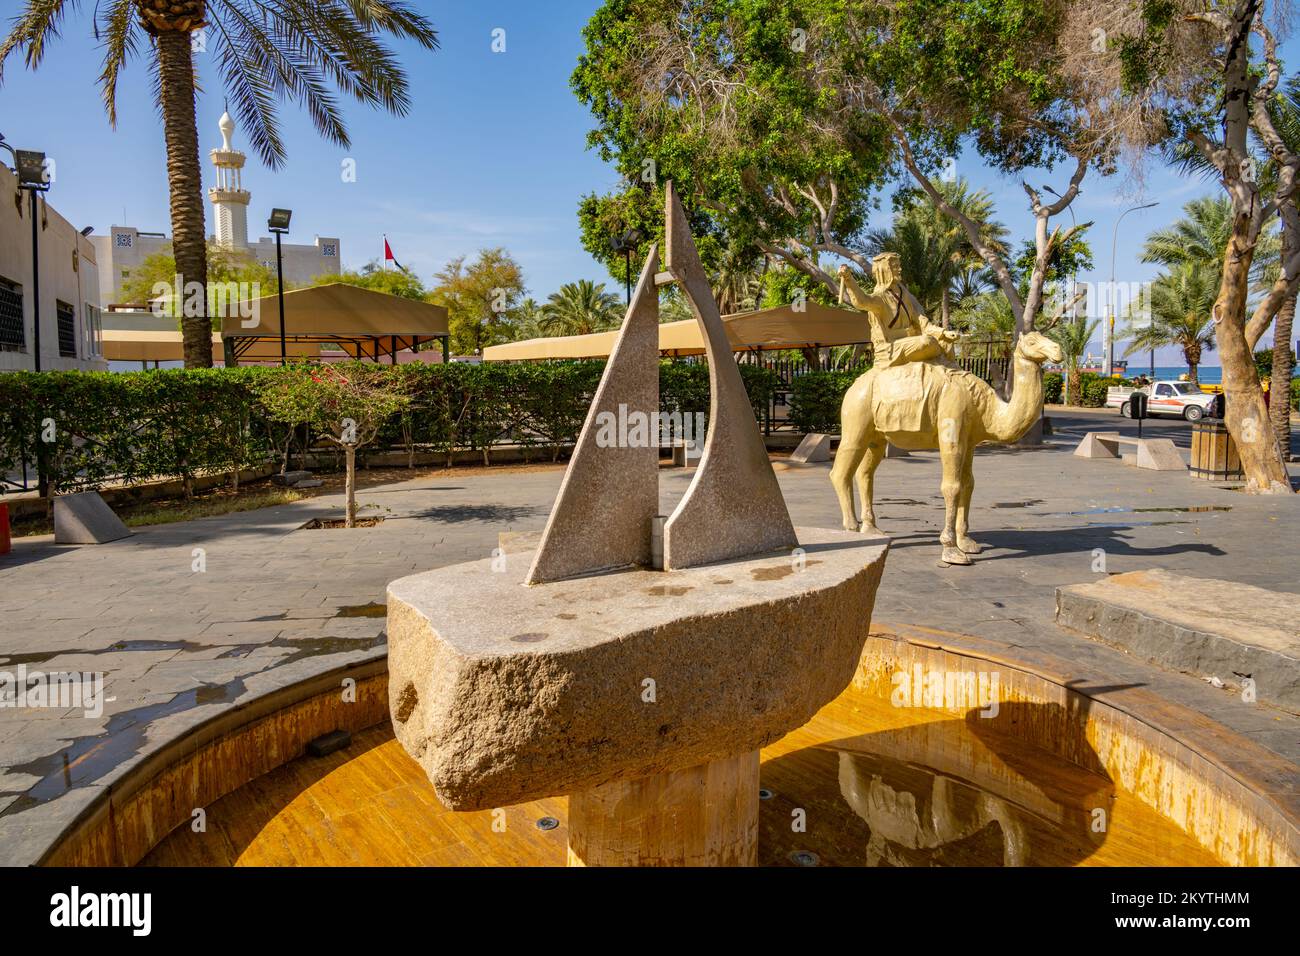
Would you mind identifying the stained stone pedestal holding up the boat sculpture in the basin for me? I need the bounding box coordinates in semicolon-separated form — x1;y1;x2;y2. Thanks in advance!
568;750;758;866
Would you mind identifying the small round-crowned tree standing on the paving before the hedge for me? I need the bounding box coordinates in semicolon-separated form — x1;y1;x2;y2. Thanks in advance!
259;362;411;528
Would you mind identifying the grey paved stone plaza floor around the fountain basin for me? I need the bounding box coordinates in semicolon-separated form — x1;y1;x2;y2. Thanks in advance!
0;411;1300;864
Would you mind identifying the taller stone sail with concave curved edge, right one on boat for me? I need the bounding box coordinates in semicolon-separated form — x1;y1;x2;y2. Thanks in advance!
665;182;798;571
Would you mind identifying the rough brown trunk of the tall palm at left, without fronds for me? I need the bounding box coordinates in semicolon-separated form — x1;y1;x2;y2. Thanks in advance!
157;30;212;368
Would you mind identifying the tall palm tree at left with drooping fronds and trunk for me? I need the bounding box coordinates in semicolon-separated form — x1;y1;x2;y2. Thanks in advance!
0;0;438;368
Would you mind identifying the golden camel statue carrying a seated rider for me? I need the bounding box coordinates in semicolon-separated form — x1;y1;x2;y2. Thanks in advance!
831;261;1062;564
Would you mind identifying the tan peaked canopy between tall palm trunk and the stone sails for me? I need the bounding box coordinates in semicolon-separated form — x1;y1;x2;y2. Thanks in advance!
221;282;449;362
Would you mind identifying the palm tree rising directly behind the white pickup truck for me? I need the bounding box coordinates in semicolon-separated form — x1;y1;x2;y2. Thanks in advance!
1126;260;1222;382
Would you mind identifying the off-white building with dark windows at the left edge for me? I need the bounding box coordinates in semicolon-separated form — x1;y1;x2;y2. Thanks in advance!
0;164;108;371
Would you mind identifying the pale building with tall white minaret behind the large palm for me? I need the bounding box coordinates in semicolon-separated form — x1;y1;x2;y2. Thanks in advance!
91;113;342;306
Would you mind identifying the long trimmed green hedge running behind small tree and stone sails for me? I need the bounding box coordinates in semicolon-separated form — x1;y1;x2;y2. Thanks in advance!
0;362;776;492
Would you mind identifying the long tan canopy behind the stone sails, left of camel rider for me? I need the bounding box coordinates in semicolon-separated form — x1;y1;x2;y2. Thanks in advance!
484;302;871;362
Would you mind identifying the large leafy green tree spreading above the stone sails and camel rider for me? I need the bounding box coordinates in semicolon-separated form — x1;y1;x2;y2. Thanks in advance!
572;0;1122;330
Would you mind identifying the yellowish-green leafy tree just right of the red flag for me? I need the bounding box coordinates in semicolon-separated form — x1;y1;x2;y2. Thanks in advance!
429;247;525;355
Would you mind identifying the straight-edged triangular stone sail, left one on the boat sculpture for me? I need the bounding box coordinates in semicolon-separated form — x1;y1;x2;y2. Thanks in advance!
527;246;660;584
